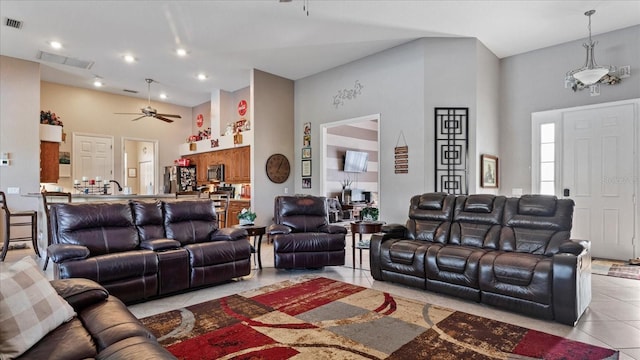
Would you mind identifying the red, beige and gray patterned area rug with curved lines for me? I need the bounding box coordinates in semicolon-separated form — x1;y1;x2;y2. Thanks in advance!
141;277;618;360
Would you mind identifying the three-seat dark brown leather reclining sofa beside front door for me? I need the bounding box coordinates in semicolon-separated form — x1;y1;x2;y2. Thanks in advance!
370;193;591;325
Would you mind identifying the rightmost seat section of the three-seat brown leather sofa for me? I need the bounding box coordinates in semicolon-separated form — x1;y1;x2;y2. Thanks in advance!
480;195;575;319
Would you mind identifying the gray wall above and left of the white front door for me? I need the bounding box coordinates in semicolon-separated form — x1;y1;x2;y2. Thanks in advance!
499;26;640;195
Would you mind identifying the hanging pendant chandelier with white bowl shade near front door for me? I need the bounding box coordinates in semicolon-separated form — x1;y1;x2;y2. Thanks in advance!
565;10;631;96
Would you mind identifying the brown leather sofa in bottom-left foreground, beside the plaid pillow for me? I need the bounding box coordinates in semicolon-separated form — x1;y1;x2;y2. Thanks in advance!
18;279;176;360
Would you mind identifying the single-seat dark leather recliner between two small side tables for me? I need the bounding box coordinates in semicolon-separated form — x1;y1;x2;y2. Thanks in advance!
267;196;347;269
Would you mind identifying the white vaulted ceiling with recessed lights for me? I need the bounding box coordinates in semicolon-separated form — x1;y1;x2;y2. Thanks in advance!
0;0;640;106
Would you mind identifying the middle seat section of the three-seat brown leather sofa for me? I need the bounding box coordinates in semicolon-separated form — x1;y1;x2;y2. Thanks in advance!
426;195;506;301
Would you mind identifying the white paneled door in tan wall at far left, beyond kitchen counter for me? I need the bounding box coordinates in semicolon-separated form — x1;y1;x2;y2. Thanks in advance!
72;134;117;193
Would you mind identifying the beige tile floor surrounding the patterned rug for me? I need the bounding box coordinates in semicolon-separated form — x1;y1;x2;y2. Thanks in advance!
0;237;640;360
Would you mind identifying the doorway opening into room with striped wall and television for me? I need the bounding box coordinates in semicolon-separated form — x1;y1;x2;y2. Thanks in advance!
321;115;379;205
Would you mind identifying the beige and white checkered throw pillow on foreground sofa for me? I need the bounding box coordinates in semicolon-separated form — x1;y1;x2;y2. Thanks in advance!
0;257;76;359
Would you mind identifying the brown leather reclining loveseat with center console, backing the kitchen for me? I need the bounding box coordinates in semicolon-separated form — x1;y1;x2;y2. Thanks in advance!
47;200;251;303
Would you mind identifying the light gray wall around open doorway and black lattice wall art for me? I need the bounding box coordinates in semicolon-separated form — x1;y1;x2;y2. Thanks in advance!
295;38;498;222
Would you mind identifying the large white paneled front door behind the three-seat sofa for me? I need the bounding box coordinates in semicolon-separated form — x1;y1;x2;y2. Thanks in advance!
561;104;637;260
